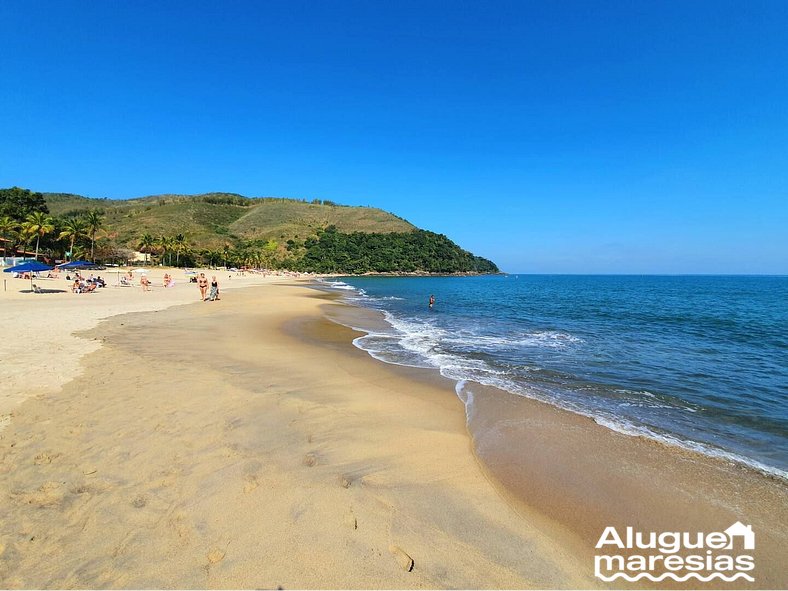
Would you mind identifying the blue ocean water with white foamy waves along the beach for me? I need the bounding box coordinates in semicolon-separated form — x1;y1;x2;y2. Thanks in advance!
323;275;788;478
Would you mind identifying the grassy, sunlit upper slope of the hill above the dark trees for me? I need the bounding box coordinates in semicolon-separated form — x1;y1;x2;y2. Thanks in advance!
44;193;415;248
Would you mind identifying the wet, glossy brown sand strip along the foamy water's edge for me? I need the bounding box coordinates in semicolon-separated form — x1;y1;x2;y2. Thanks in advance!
318;284;788;588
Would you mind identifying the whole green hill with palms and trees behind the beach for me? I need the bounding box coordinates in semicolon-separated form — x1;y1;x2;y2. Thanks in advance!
0;187;498;273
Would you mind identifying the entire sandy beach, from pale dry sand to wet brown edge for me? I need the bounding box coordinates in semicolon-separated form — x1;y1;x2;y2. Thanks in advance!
0;276;788;588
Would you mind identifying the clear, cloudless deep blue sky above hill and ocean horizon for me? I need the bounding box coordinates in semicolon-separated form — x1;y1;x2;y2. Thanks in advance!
0;0;788;274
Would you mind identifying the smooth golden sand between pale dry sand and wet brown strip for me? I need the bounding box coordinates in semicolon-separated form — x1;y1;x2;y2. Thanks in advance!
0;285;594;588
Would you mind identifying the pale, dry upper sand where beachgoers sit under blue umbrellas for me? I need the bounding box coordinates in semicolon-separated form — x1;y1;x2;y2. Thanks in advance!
0;267;290;420
